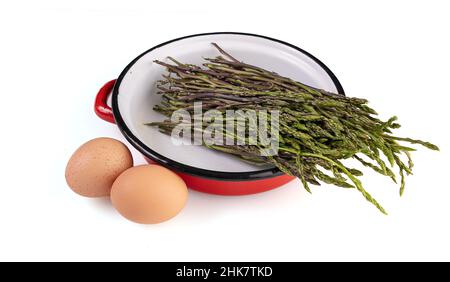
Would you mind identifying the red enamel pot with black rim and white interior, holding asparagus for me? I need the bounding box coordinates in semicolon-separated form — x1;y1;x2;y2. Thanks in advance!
95;32;344;195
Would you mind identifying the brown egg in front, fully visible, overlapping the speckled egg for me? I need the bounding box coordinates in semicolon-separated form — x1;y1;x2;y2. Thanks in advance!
111;165;188;224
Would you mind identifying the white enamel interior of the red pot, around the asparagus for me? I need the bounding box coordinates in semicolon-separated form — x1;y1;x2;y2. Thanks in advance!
118;34;337;172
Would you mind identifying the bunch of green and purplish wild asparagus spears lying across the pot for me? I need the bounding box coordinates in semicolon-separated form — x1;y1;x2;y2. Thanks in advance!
148;43;439;214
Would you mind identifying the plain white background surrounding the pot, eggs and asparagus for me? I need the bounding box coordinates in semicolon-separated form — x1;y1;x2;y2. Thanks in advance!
0;0;450;261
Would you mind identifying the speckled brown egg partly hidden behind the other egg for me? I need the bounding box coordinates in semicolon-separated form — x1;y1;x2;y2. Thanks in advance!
66;137;133;197
